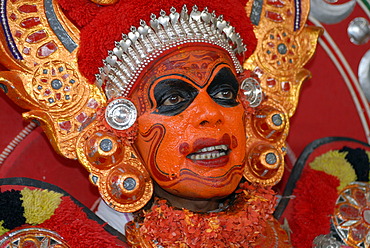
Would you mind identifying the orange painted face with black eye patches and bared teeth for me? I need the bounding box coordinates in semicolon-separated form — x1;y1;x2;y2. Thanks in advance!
132;47;246;199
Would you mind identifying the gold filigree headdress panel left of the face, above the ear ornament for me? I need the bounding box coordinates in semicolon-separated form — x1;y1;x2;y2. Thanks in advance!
0;0;106;159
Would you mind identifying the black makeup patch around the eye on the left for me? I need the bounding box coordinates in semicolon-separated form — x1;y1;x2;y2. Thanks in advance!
154;79;198;116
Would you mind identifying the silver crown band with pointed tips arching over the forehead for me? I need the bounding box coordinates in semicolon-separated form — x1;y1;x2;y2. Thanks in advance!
95;5;246;99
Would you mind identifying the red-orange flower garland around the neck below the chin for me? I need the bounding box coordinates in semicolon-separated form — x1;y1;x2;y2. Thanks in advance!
140;183;275;247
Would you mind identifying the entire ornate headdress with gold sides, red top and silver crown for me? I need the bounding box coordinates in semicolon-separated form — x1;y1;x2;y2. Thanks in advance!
0;0;320;212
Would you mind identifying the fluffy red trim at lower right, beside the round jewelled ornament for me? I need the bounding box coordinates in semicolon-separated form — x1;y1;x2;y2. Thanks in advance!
289;168;339;248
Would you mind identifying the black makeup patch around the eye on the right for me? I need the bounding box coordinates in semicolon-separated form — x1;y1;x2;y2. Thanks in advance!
207;67;239;107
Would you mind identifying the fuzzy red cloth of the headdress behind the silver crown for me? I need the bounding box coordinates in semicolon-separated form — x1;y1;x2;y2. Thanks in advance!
58;0;257;83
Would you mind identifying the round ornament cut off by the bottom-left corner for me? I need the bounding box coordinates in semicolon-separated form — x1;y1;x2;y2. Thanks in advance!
0;227;69;248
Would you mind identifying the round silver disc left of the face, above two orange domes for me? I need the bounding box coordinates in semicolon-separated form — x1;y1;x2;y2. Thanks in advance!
105;98;137;130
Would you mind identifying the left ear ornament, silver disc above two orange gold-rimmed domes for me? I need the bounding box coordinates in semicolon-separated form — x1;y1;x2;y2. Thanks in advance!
77;98;153;212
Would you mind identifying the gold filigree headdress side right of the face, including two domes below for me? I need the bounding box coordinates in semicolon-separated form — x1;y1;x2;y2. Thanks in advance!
243;0;321;185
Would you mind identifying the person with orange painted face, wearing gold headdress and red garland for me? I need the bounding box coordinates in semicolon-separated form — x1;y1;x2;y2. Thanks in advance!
0;0;320;247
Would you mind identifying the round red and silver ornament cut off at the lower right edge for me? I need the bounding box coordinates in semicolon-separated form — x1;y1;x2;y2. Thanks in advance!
332;182;370;248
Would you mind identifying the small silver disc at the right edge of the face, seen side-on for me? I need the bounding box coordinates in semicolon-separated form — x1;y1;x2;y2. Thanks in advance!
240;77;263;108
